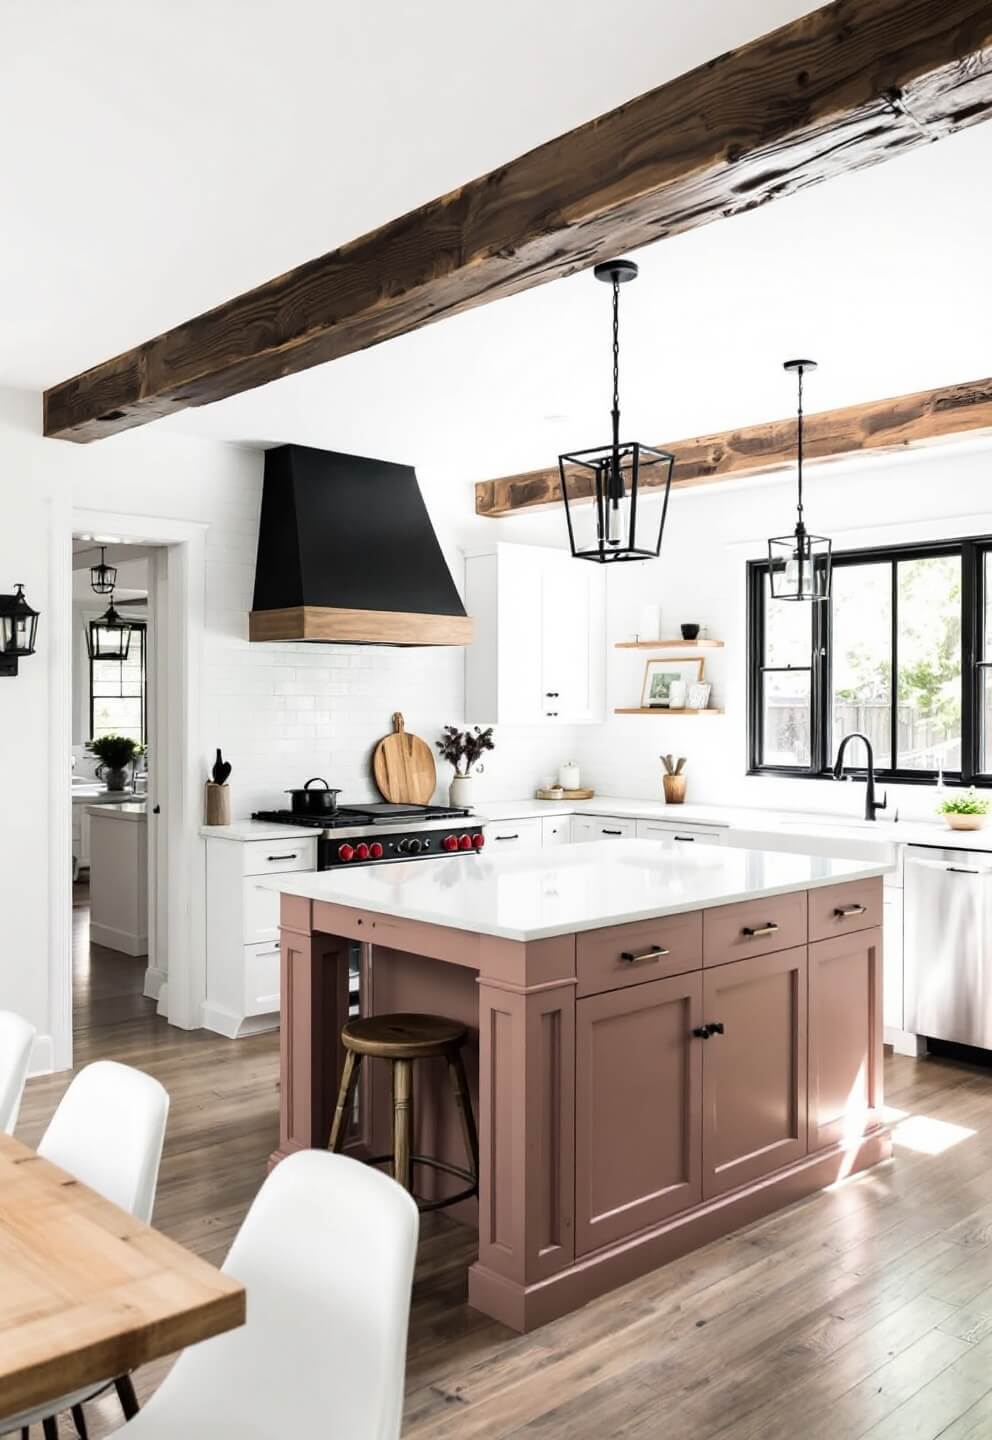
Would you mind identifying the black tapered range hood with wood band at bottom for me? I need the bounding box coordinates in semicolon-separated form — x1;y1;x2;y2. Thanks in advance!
249;445;472;645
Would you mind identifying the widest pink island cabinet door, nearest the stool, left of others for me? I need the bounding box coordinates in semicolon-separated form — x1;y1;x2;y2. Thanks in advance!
576;971;703;1254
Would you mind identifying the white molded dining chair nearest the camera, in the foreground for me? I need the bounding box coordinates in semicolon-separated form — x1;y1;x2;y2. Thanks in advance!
120;1151;419;1440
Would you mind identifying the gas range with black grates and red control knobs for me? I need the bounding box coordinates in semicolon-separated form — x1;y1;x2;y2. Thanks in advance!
252;801;485;870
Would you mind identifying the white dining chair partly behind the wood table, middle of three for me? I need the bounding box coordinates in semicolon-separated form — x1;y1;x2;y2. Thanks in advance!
3;1060;168;1440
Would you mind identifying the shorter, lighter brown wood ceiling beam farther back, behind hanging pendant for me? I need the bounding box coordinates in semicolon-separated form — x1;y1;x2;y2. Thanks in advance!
475;379;992;518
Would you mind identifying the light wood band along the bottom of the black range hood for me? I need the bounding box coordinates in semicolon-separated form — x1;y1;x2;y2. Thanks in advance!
248;605;472;645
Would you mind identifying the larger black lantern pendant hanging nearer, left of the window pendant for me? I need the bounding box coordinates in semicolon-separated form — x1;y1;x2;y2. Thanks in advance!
559;261;675;564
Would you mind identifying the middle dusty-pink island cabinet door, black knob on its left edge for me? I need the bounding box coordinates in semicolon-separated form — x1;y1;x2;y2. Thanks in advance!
701;946;806;1200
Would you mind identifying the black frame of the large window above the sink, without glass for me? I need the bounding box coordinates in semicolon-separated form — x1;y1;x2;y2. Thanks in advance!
747;536;992;788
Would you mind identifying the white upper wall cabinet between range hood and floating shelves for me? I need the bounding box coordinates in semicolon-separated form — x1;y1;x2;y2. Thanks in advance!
465;544;606;724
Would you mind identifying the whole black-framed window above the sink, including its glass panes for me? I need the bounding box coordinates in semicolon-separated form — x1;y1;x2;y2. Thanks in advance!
747;537;992;785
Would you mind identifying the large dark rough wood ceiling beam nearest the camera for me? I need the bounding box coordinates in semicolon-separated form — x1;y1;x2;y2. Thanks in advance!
45;0;992;441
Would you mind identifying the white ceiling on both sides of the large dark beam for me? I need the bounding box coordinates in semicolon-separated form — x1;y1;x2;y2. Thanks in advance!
0;0;992;480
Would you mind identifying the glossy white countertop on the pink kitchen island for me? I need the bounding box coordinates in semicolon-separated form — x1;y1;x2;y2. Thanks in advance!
258;840;893;940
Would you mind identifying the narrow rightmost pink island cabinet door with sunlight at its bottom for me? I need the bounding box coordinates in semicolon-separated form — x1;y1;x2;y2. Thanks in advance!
809;930;883;1151
